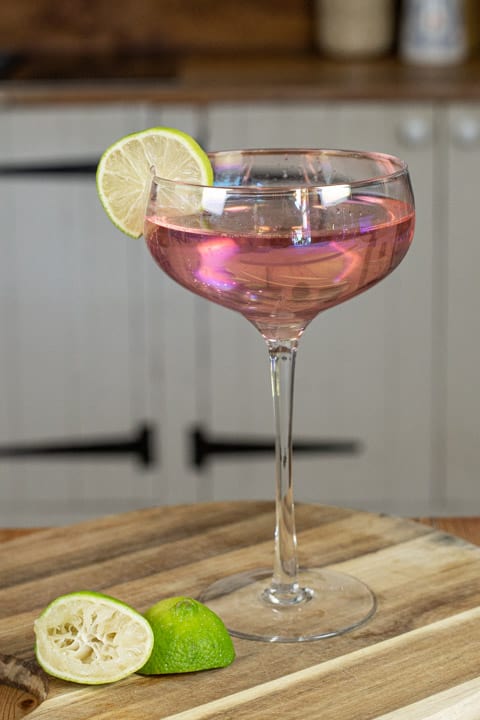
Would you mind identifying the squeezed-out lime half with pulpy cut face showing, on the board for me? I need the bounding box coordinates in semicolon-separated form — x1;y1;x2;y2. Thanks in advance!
34;590;153;685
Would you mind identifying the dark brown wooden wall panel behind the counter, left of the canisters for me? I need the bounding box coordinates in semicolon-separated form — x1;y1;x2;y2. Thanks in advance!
0;0;313;53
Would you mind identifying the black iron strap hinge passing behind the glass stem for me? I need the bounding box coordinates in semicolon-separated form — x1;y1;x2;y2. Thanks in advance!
190;425;362;468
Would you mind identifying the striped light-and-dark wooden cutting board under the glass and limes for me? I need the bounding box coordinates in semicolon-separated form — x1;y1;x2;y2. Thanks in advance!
0;502;480;720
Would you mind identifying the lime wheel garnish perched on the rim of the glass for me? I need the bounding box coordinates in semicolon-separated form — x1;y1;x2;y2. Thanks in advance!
97;127;213;238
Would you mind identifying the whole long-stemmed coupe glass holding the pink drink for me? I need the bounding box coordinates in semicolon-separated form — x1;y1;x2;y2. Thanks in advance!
145;150;415;642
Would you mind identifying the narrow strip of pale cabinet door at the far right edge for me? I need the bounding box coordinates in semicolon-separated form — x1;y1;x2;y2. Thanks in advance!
444;104;480;514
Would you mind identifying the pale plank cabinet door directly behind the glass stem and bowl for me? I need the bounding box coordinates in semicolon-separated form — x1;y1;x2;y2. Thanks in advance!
200;103;435;513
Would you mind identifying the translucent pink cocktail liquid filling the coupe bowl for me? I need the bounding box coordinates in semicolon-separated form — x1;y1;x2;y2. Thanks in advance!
145;197;414;339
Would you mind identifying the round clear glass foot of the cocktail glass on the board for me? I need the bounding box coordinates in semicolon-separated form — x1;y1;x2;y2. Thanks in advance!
199;568;376;642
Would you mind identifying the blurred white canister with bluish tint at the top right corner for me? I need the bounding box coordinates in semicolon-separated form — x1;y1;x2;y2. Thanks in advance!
400;0;468;65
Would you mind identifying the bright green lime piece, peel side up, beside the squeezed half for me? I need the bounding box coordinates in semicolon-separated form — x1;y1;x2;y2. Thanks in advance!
138;597;235;675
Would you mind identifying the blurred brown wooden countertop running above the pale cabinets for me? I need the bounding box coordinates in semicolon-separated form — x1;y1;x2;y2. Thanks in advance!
0;54;480;104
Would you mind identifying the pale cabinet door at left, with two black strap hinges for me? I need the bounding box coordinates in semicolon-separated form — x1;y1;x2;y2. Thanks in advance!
0;105;201;525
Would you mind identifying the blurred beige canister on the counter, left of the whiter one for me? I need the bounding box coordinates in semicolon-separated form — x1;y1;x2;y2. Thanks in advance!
315;0;395;59
